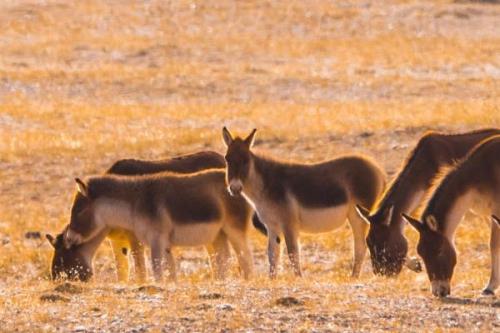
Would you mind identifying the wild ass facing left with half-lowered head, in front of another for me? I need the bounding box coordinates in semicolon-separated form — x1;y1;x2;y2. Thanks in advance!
64;169;253;281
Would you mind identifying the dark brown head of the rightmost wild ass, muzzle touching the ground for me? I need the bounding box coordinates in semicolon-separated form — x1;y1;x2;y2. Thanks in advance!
402;214;457;297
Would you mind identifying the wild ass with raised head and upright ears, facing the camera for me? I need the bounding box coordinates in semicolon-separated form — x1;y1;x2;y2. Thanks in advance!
222;127;385;278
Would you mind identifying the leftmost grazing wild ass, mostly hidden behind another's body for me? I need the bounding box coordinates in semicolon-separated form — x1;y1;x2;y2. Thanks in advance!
47;151;265;281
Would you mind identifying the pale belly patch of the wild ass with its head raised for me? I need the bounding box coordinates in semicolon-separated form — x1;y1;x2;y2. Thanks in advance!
299;205;349;234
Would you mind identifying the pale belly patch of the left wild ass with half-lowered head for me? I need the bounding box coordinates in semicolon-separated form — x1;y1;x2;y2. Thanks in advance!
170;223;222;246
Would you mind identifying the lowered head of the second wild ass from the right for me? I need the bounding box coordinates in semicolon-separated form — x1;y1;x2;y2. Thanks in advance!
356;205;408;276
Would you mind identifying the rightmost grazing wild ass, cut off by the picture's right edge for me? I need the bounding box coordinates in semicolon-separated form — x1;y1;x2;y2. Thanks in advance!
403;136;500;297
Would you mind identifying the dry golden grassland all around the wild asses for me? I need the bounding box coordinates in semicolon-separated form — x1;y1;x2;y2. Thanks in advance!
0;0;500;332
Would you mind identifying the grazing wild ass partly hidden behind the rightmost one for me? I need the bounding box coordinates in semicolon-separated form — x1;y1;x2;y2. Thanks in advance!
357;129;500;275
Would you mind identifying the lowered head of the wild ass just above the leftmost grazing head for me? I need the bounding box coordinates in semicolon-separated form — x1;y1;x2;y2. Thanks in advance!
64;178;104;249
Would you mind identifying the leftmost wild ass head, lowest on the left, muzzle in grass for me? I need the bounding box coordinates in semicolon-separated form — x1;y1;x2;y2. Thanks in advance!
45;228;93;281
